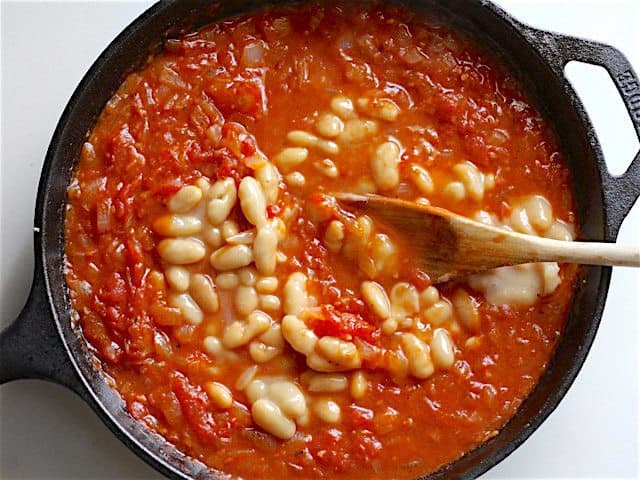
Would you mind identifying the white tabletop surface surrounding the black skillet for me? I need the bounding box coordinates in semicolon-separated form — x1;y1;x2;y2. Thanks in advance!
0;0;640;479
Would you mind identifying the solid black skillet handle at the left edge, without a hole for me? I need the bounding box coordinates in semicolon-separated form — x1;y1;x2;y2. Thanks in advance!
0;262;83;394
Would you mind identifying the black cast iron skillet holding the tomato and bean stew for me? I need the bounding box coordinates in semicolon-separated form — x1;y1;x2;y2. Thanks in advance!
0;0;640;479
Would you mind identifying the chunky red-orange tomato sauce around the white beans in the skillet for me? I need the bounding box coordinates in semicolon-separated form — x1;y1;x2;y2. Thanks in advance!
65;3;575;479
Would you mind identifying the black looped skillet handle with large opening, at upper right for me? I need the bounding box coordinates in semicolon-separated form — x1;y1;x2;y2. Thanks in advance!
528;28;640;238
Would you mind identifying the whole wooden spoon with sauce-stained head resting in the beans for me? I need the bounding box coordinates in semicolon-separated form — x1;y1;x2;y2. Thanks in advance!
335;193;640;283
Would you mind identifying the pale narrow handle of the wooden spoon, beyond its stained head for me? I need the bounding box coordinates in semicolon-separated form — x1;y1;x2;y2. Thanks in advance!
528;237;640;267
